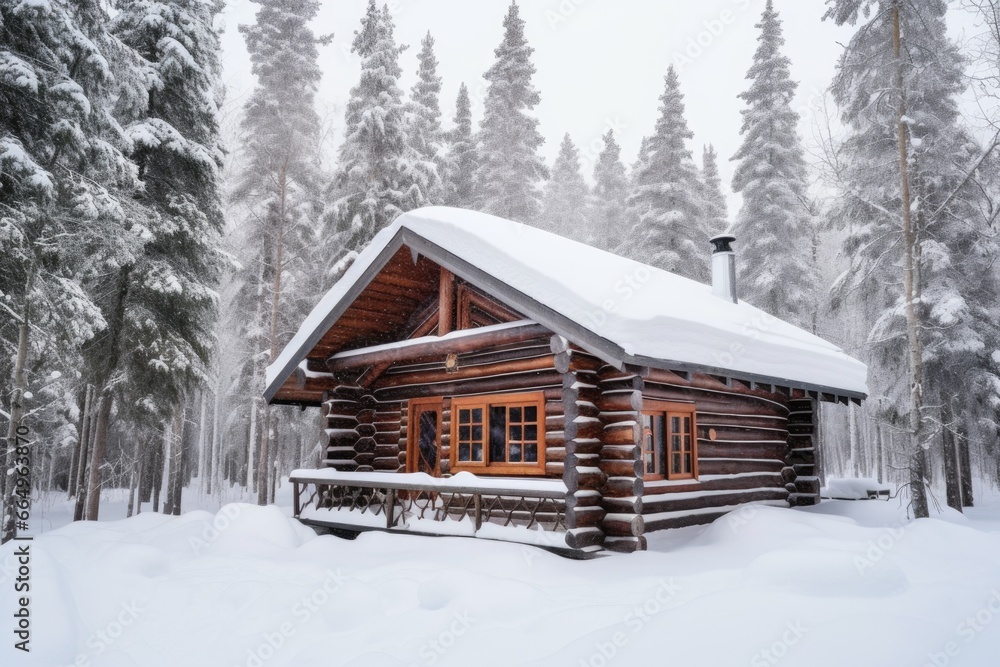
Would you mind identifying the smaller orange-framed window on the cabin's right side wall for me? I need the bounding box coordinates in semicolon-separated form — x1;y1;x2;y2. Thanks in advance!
642;401;698;480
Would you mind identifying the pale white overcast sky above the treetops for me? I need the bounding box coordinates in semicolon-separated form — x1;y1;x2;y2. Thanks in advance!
217;0;976;216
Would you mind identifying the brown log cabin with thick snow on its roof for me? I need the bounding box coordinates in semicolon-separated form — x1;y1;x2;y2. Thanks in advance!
265;207;867;555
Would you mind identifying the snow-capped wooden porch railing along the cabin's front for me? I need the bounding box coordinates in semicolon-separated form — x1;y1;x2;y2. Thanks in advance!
290;471;566;548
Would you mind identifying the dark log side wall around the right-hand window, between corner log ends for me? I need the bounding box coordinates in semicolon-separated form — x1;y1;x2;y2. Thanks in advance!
641;369;792;531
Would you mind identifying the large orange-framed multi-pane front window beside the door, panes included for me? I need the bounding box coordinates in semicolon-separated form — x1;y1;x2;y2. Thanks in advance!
451;393;545;474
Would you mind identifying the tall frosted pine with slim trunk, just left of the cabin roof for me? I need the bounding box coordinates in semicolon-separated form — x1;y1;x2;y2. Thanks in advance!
233;0;333;504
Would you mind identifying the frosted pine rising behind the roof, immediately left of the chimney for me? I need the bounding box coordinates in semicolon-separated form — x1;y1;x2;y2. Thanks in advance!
624;65;709;282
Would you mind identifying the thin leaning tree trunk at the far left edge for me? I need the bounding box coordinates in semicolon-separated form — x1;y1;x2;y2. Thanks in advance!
0;266;35;543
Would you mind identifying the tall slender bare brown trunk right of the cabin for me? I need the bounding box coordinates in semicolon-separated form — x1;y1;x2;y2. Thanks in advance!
892;0;929;518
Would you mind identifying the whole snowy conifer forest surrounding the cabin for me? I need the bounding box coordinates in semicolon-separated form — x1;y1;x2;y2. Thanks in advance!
0;0;1000;535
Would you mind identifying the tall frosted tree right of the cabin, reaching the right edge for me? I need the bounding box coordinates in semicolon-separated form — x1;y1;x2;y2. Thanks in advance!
826;0;1000;516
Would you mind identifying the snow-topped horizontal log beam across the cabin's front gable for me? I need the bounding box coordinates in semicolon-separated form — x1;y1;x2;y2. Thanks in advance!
326;323;551;373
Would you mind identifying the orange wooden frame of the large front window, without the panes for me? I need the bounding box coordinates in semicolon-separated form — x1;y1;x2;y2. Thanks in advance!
449;391;545;475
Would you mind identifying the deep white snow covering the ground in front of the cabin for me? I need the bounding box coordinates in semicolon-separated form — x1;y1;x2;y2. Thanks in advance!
0;487;1000;667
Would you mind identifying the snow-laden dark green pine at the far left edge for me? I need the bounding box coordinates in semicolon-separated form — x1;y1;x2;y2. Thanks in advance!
0;0;140;539
